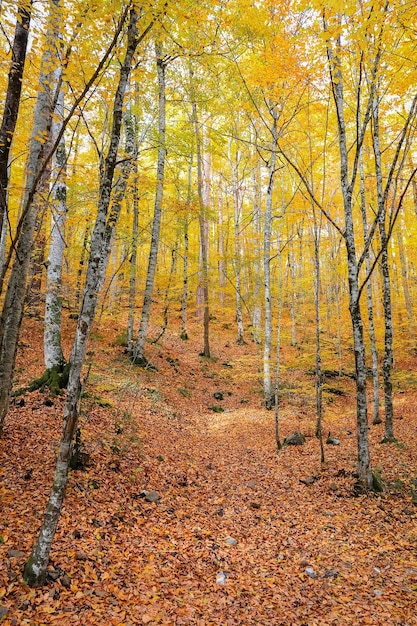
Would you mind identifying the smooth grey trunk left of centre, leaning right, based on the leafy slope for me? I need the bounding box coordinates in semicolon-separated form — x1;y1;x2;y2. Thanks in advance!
132;46;166;366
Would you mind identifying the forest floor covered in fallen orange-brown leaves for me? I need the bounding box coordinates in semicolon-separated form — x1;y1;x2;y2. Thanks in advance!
0;310;417;626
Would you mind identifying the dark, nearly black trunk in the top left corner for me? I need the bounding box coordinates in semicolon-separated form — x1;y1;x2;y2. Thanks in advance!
0;0;32;233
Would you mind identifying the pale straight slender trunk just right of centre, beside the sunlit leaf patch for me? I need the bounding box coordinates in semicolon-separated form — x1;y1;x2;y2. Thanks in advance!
263;106;278;409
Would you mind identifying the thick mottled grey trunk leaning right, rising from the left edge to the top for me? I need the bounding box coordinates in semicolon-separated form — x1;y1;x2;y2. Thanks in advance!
0;0;59;434
